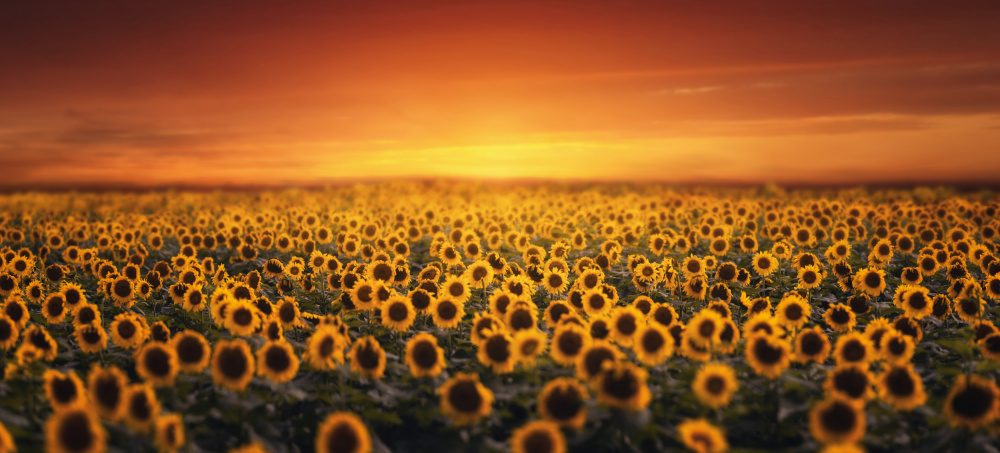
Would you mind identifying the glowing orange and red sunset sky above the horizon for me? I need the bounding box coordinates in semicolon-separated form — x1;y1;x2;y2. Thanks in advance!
0;0;1000;188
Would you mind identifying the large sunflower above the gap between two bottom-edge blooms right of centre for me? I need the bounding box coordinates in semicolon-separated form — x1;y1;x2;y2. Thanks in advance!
592;361;652;411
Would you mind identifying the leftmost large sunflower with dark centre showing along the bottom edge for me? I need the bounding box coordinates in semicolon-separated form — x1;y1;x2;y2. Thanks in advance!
45;406;108;453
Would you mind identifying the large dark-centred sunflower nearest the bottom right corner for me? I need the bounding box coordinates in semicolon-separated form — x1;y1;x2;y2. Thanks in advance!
942;375;1000;430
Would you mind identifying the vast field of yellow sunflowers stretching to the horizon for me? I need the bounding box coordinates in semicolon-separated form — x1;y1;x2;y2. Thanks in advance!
0;182;1000;453
